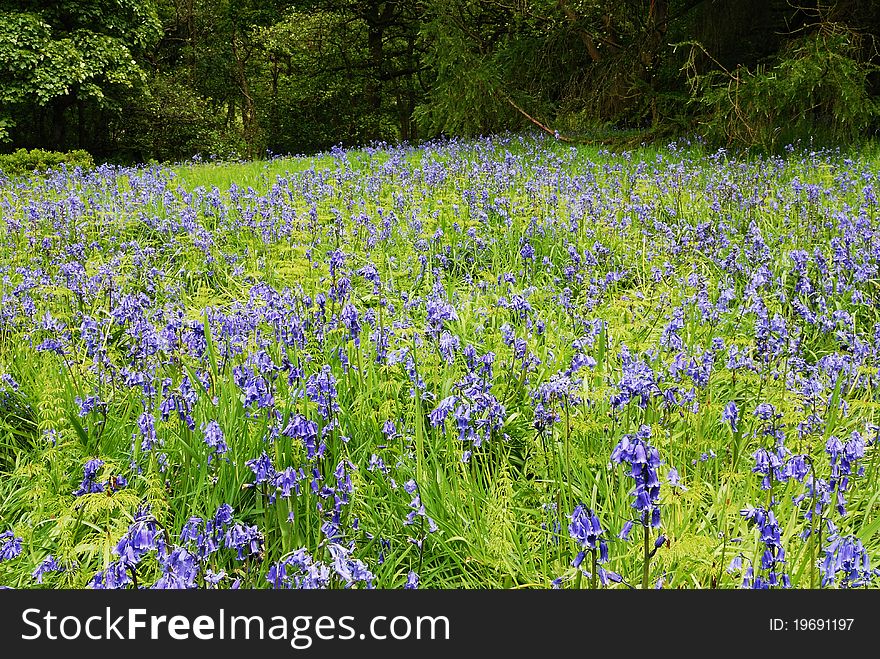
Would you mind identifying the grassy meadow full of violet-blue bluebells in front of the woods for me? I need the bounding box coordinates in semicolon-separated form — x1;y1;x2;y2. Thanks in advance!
0;136;880;589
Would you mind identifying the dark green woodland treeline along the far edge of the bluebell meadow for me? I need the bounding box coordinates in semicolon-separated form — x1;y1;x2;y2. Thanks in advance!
0;0;880;162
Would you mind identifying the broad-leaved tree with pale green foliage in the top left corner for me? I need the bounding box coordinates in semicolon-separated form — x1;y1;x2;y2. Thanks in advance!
0;0;160;148
